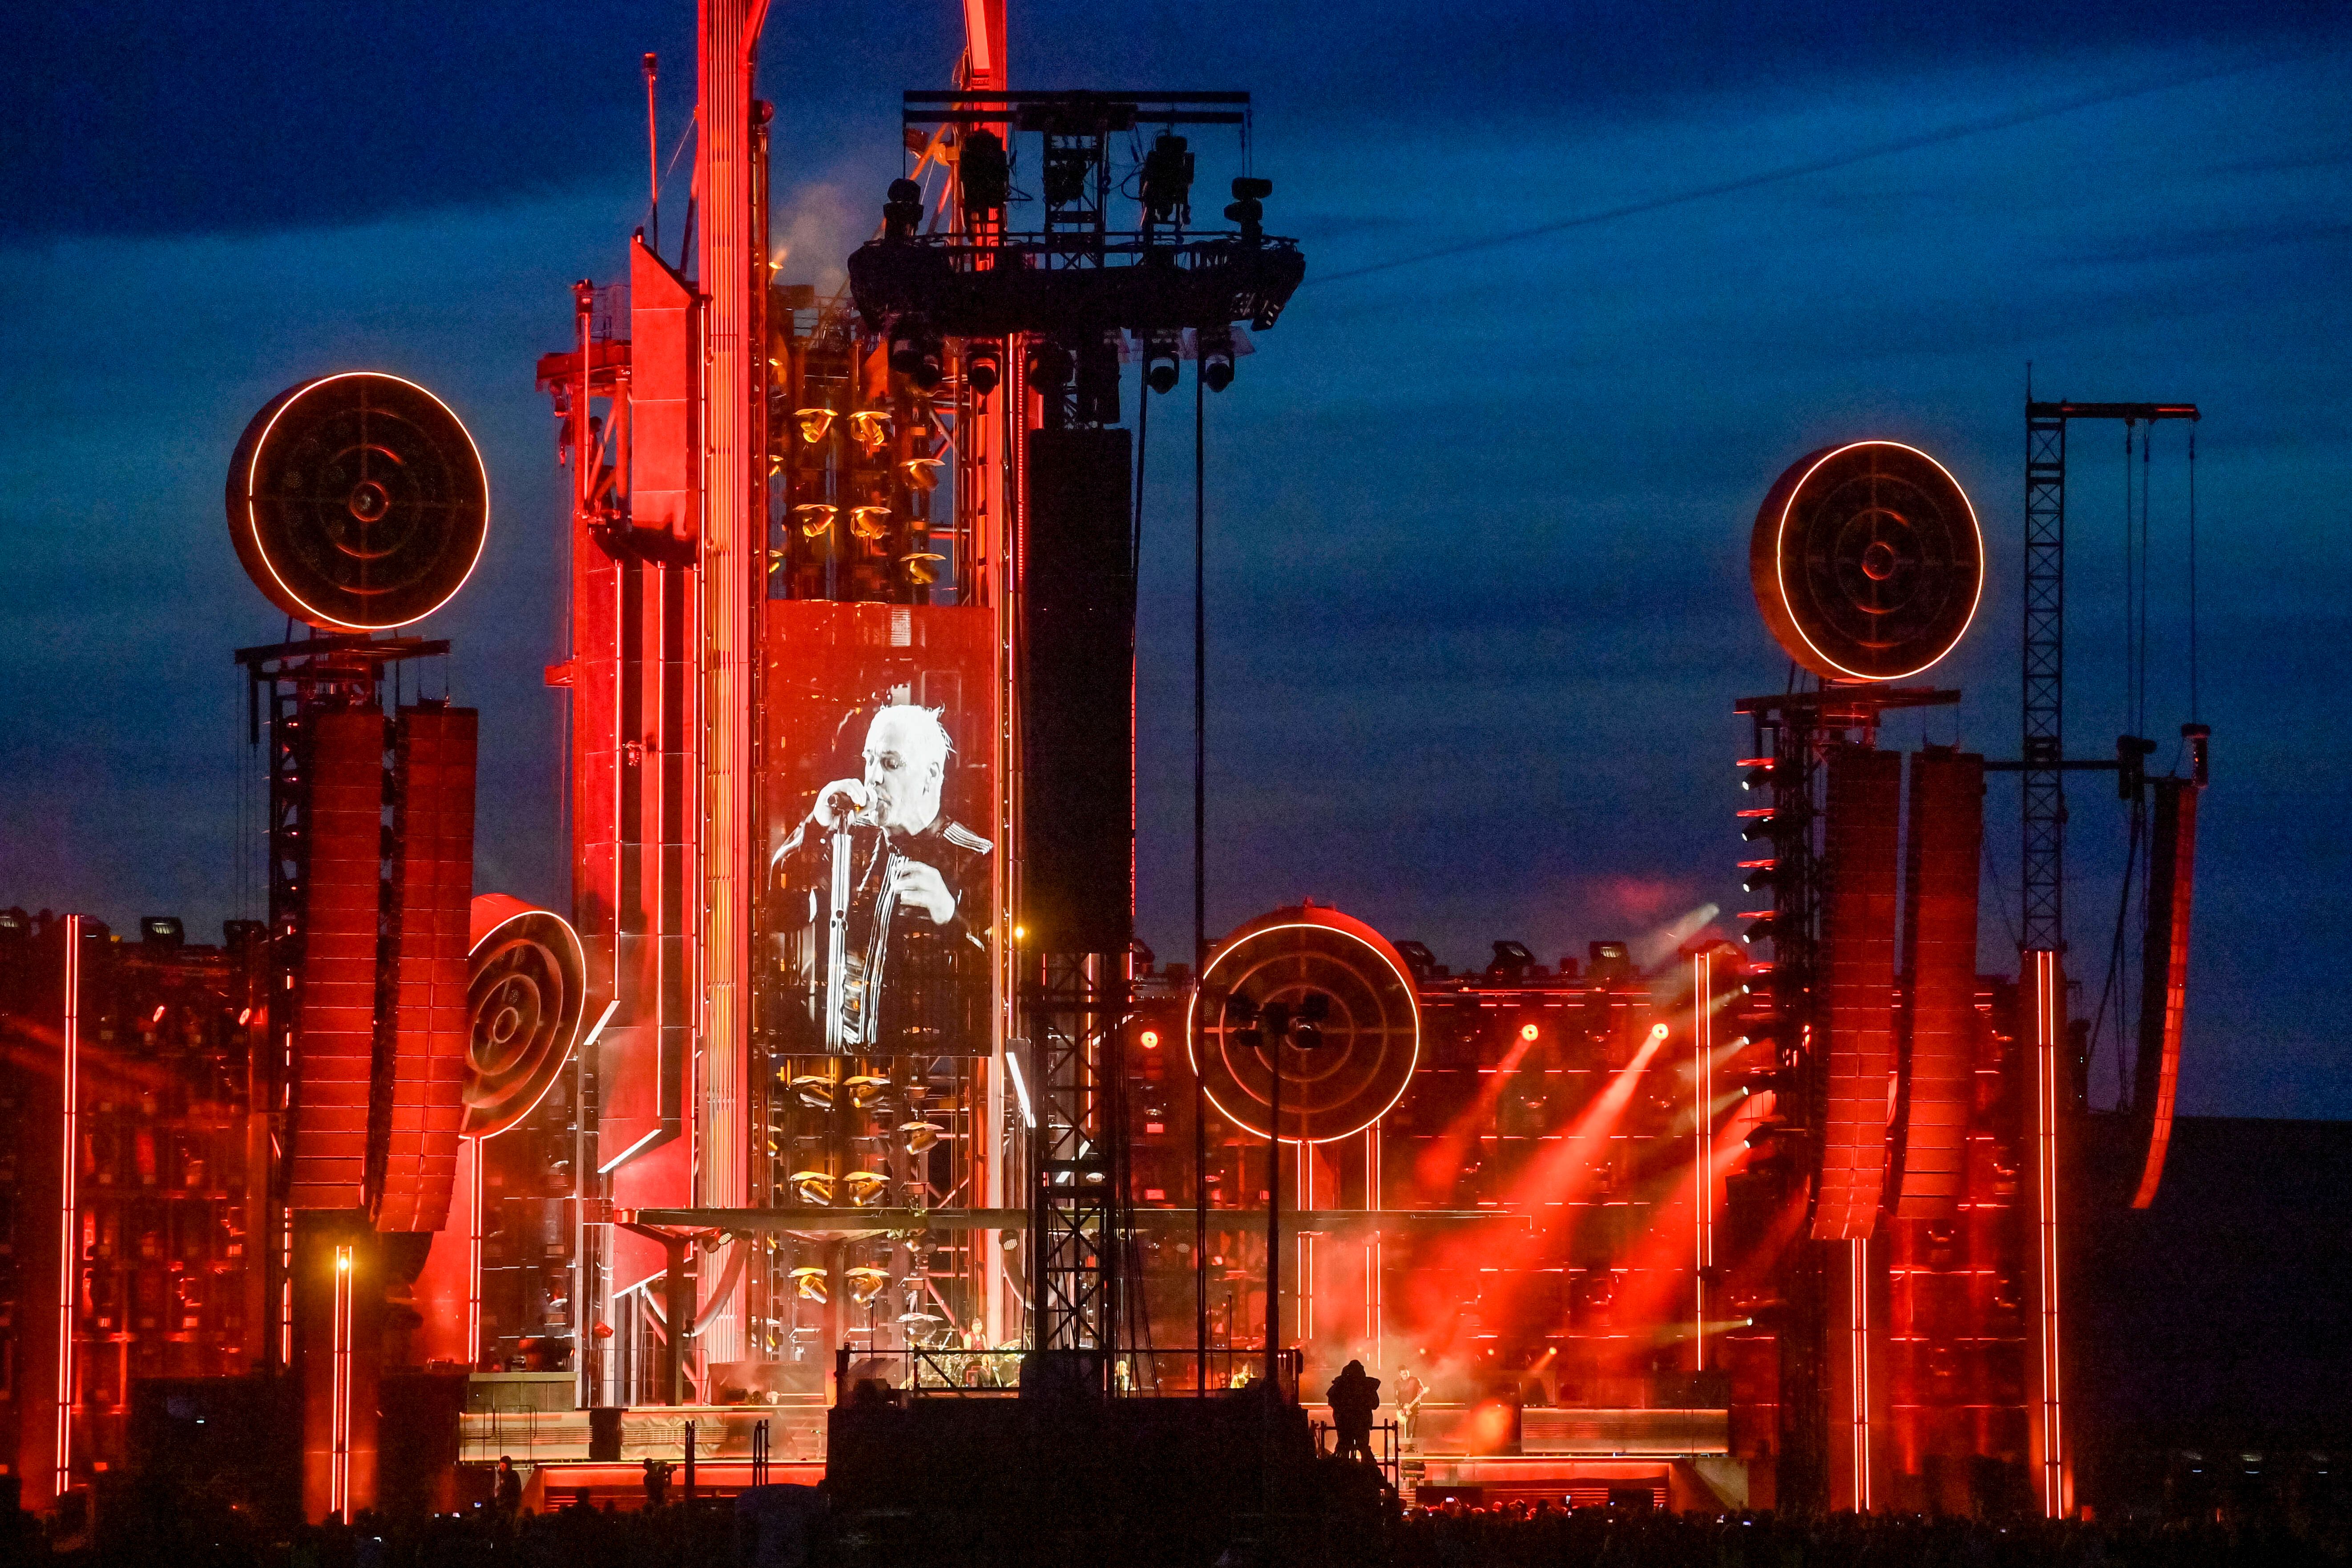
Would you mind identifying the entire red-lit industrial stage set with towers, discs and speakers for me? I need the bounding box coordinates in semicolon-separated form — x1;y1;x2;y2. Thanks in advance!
0;0;2206;1519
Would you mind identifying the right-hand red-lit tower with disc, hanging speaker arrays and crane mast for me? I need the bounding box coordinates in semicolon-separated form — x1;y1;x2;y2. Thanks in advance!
1727;416;2208;1516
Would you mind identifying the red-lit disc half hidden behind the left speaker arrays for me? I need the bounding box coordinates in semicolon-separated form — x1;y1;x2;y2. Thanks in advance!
464;893;588;1138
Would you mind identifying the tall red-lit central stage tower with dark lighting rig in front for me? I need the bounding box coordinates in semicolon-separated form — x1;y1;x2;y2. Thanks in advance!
539;5;1303;1406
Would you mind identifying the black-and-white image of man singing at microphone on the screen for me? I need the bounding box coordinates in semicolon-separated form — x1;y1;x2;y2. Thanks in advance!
769;703;990;1056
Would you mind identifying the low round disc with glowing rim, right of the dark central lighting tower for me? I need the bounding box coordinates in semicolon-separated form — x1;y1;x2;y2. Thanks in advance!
1186;905;1420;1142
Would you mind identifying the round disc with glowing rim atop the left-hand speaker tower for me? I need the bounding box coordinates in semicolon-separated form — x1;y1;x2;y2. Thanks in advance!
228;371;489;633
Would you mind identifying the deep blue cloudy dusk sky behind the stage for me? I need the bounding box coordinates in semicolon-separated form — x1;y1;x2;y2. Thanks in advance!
0;0;2352;1117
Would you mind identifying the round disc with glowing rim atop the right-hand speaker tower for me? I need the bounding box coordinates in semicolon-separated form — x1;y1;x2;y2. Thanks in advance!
1747;442;1985;682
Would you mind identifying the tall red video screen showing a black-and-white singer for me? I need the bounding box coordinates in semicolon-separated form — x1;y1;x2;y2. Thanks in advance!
760;600;1002;1058
